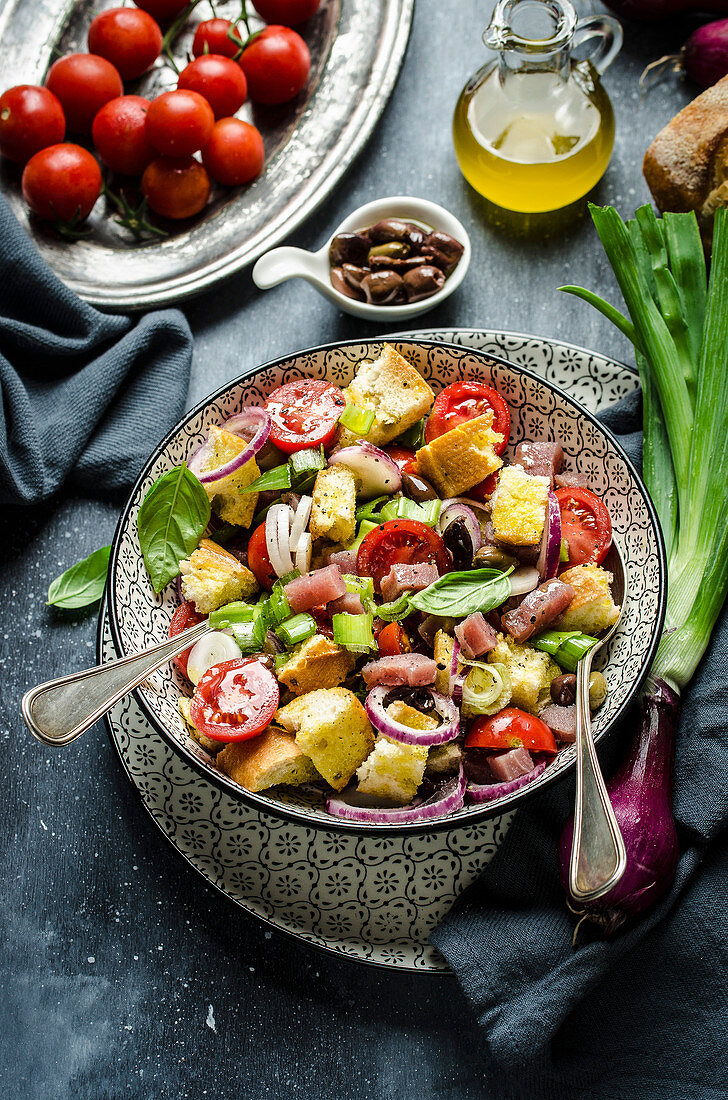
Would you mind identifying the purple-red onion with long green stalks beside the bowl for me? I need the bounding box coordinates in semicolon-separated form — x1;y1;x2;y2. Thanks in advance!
561;206;728;930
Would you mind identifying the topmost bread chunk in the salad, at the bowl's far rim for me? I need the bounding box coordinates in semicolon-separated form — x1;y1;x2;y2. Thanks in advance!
339;344;434;447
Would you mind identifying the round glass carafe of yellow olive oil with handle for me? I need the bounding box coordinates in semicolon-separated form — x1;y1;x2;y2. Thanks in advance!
453;0;622;213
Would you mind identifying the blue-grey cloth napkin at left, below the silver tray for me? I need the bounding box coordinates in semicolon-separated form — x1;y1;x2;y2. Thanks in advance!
0;196;192;504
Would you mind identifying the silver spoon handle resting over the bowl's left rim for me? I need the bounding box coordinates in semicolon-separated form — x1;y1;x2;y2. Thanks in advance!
21;619;209;745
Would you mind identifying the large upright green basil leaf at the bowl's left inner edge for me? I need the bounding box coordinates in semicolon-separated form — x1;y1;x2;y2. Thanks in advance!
136;463;210;592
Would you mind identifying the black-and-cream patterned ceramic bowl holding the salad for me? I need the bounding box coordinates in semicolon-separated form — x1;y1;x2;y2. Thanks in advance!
109;340;665;834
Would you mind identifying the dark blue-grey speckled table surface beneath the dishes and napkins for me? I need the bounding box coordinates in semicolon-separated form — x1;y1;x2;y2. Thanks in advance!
0;0;695;1100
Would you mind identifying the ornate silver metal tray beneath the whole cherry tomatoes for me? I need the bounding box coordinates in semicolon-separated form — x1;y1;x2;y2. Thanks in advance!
0;0;413;311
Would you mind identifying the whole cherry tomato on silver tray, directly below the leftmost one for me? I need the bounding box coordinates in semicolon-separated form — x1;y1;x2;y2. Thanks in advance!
22;142;101;224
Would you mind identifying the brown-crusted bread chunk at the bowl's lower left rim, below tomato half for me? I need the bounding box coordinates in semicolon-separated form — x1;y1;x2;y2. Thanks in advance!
217;726;318;791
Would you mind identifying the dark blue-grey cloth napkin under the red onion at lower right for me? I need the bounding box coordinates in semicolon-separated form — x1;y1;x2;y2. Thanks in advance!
432;398;728;1100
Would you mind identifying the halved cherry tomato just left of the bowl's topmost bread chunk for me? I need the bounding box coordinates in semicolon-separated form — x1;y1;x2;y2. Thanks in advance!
265;378;346;454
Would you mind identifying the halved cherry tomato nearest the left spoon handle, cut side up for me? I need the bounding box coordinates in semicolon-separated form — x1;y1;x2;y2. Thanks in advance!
189;657;280;741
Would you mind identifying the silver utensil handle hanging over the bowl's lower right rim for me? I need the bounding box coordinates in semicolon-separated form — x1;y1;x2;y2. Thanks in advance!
569;651;627;901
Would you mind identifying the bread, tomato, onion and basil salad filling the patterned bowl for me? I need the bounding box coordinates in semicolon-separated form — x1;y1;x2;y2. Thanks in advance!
149;344;619;824
